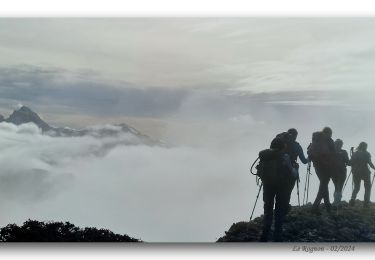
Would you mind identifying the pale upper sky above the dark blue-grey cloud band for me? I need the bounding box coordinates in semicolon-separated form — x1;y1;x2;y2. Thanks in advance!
0;18;375;91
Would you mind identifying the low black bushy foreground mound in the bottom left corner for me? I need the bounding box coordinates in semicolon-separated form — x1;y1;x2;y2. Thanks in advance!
0;220;142;242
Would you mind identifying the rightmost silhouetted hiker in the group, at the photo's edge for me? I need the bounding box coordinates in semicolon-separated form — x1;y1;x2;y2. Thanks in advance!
349;142;375;207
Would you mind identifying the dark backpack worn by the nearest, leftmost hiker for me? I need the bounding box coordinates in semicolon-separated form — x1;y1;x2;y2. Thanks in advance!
256;149;286;183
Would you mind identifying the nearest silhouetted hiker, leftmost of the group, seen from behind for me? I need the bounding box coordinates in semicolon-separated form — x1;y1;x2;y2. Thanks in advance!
257;137;297;242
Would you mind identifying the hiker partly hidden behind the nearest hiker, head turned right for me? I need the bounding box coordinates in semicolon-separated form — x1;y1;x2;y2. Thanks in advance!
286;128;308;209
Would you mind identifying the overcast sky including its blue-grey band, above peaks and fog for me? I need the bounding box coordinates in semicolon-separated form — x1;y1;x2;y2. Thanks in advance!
0;18;375;124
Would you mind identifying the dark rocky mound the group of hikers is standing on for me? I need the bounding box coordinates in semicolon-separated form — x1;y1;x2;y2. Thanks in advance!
217;200;375;242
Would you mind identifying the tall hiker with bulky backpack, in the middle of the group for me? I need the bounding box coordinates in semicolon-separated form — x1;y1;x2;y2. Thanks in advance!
307;127;337;214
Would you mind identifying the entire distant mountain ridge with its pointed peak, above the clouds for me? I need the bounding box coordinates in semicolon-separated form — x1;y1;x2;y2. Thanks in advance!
0;106;162;145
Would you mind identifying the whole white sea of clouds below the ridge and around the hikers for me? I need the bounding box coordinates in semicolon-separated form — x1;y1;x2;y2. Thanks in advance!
0;90;375;242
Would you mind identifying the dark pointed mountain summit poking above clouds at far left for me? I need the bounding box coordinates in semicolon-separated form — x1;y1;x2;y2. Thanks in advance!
5;106;51;131
